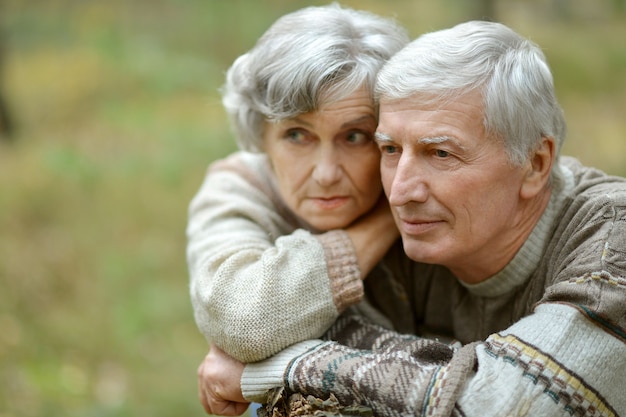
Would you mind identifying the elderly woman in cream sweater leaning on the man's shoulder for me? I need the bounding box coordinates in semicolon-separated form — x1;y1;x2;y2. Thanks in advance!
187;0;408;376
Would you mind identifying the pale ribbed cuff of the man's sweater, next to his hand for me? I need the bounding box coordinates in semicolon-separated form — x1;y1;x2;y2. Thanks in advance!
241;339;325;403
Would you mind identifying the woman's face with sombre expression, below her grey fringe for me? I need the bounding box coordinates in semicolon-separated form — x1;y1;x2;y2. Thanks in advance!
263;89;382;231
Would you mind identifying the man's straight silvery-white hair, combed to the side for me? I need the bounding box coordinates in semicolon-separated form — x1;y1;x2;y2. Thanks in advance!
376;21;566;165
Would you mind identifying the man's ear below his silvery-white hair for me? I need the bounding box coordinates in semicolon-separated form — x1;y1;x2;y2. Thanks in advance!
520;136;556;199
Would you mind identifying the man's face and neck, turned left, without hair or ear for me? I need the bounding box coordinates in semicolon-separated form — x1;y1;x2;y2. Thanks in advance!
376;93;525;282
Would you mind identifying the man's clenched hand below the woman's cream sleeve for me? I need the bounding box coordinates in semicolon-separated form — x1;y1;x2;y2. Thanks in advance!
198;345;250;416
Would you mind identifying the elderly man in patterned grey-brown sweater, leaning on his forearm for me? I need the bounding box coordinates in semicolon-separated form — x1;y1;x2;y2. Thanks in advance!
199;22;626;416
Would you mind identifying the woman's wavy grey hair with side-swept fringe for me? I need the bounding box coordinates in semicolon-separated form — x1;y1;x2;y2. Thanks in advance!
221;4;409;152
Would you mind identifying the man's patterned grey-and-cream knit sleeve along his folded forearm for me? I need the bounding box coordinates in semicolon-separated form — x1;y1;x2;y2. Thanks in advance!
242;304;626;416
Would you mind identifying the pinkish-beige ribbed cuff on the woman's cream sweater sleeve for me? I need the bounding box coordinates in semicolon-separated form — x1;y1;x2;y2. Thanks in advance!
317;230;364;313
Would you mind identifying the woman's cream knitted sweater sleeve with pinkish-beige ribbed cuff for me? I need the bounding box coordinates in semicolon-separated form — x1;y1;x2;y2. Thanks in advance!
187;154;363;362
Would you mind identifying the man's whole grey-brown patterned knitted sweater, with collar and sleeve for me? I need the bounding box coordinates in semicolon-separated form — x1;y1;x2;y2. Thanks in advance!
241;158;626;416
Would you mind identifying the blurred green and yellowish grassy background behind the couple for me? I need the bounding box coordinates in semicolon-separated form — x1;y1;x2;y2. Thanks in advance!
0;0;626;417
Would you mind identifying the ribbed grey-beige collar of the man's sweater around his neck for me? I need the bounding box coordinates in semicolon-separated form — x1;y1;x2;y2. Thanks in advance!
459;165;574;297
